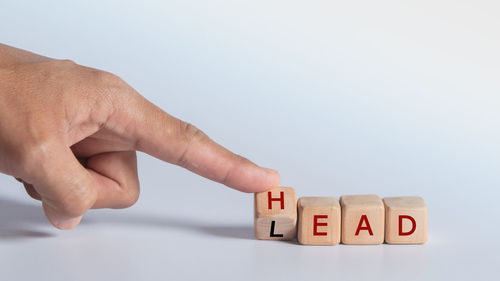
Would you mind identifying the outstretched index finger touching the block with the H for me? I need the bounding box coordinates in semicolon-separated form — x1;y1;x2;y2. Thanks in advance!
108;87;280;192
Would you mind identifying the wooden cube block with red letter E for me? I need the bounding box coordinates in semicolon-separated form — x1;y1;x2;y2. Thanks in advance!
297;197;340;245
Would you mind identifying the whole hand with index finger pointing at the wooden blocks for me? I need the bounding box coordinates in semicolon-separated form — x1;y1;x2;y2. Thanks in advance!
0;44;280;229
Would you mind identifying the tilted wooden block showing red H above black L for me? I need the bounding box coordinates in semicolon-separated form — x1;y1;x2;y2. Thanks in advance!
254;187;297;240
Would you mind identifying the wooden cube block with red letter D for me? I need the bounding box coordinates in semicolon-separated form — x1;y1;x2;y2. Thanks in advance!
383;196;427;244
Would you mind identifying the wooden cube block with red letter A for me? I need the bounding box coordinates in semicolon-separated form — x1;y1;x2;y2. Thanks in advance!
340;195;384;244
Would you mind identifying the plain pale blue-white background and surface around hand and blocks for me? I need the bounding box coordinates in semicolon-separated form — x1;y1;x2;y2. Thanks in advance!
0;0;500;281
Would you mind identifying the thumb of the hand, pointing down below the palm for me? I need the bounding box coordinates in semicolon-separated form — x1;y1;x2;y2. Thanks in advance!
25;141;97;229
